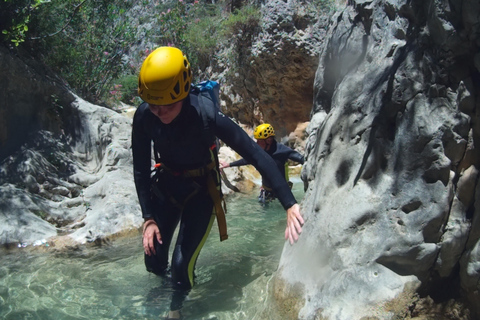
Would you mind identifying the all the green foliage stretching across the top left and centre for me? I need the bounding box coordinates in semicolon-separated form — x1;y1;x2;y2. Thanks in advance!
0;0;262;105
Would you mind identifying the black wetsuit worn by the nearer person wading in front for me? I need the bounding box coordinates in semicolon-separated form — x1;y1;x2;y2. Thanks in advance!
132;93;296;310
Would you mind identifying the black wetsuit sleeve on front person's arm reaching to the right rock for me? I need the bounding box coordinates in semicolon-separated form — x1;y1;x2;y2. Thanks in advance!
213;112;297;210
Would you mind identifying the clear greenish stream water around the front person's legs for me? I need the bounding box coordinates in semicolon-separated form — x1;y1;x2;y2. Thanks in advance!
0;181;303;320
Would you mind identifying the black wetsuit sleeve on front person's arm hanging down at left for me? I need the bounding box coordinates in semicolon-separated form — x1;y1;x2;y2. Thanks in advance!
132;105;153;219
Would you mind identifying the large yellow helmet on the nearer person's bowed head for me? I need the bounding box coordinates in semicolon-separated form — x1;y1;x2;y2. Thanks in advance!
138;47;192;105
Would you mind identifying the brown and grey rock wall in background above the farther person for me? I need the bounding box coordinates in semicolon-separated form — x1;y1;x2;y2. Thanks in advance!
220;0;327;136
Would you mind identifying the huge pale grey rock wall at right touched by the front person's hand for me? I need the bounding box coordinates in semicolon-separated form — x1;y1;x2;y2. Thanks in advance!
276;0;480;319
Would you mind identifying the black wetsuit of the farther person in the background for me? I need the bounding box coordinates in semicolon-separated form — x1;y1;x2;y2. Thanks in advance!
230;140;305;200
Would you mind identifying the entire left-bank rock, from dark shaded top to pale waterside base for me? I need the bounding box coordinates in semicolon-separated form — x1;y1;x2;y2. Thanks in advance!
0;51;143;245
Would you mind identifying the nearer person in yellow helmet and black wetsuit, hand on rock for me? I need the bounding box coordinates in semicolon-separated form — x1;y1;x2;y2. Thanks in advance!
132;47;304;319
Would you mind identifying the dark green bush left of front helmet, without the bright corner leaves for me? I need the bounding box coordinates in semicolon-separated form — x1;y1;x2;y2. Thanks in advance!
33;0;134;102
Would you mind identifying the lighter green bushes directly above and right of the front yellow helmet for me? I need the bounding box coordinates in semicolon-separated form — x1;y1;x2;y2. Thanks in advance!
139;0;261;84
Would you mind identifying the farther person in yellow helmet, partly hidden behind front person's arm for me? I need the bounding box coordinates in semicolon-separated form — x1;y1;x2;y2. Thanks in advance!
220;123;305;204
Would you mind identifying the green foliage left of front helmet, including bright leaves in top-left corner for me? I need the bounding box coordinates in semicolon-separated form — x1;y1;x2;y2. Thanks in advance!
0;0;135;102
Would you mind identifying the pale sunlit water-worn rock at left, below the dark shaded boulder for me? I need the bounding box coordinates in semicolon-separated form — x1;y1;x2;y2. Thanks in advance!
0;97;143;246
